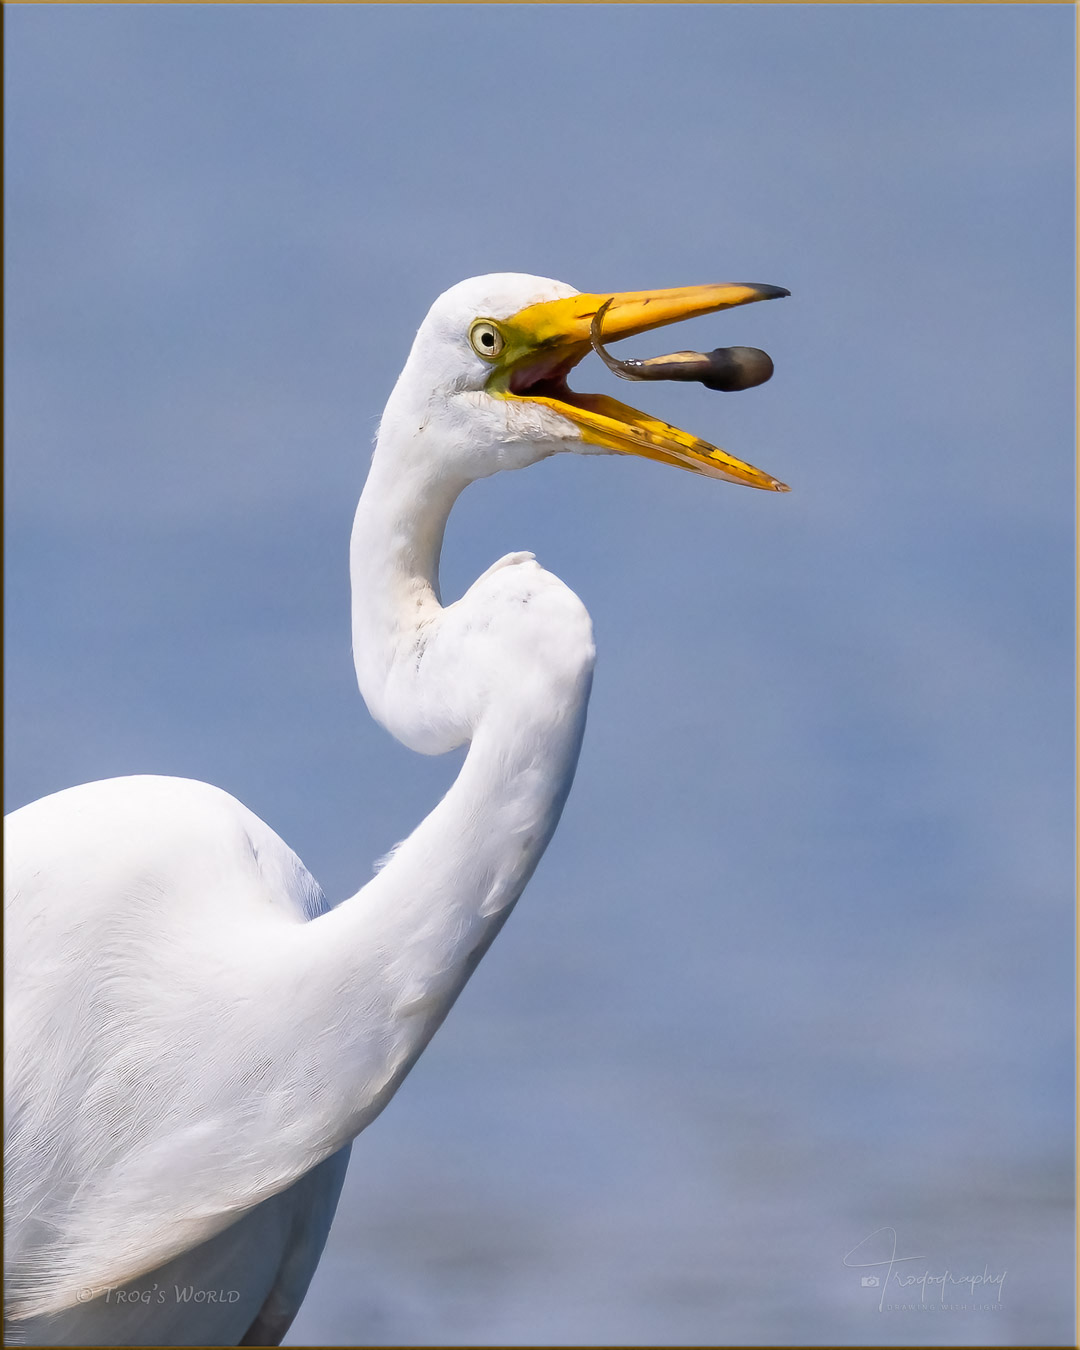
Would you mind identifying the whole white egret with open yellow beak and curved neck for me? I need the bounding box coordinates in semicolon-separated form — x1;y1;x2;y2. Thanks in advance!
4;274;786;1345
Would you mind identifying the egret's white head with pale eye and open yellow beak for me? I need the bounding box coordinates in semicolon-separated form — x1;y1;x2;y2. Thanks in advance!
382;273;787;491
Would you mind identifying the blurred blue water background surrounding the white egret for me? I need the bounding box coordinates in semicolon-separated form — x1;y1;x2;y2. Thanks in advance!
4;5;1075;1345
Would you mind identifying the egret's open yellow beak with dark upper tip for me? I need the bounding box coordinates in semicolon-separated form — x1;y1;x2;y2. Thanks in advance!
498;284;790;493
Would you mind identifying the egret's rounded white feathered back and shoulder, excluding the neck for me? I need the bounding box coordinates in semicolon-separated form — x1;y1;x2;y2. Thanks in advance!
4;778;337;1314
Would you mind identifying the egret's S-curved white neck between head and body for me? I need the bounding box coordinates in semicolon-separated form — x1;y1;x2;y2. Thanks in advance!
295;450;593;1142
